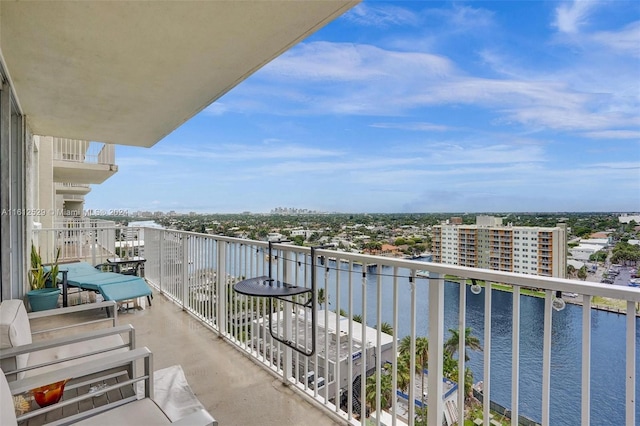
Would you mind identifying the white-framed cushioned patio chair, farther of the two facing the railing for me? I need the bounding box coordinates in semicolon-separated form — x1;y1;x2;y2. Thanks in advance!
0;299;135;380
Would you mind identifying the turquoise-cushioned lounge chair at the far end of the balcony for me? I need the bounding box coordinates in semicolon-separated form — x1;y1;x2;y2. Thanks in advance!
47;262;152;306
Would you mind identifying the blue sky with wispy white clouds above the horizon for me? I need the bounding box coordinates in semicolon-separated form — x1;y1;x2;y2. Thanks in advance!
86;0;640;213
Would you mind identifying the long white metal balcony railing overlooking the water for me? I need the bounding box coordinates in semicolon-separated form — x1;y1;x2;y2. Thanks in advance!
31;228;640;425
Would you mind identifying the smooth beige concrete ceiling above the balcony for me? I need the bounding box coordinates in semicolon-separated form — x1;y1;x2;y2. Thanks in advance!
0;0;359;147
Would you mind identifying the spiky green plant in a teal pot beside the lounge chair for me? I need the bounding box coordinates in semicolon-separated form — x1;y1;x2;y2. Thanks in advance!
27;244;60;311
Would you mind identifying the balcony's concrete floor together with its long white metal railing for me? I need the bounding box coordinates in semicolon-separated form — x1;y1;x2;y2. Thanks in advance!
34;227;640;425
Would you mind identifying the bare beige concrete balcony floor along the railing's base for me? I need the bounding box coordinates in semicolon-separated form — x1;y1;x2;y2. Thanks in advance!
57;291;337;426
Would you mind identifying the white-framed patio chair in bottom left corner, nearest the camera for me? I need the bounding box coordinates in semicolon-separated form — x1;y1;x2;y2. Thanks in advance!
0;348;217;426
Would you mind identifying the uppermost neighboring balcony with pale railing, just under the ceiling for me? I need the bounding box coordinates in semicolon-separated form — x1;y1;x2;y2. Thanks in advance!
53;138;118;184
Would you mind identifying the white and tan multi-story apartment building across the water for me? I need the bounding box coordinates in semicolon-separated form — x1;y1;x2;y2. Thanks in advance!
432;216;567;277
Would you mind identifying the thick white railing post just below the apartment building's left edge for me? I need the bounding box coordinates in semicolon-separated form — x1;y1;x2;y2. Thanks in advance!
427;273;444;425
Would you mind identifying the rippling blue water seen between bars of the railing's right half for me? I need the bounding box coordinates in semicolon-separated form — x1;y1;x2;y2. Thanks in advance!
319;267;640;425
